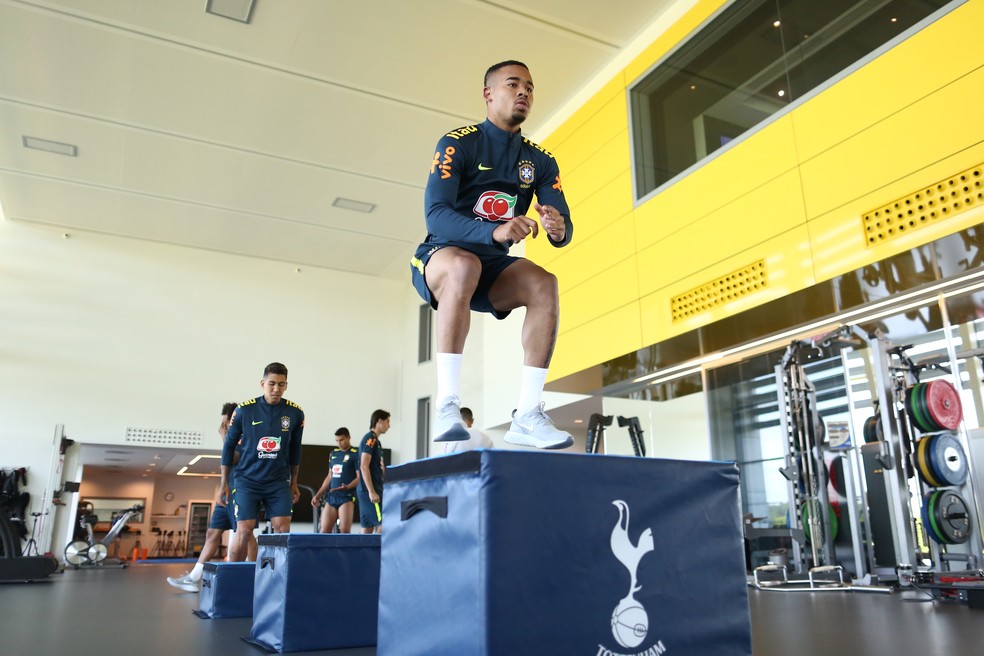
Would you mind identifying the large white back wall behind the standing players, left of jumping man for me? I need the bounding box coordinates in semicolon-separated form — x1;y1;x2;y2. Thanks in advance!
0;218;415;550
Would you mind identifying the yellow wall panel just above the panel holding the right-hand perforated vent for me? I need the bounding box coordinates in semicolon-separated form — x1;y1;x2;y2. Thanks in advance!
802;66;984;216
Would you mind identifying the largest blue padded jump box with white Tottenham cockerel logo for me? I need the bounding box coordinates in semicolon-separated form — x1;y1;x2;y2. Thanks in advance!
380;450;752;656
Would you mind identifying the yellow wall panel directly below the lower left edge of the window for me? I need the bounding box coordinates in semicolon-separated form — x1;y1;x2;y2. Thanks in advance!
636;117;796;248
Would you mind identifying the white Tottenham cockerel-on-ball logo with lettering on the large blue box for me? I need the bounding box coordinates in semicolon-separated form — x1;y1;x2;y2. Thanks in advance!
598;499;666;656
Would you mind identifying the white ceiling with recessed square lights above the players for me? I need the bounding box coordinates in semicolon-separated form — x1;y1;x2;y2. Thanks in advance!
0;0;673;278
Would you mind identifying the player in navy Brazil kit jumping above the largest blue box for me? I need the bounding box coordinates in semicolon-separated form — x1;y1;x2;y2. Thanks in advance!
411;61;574;449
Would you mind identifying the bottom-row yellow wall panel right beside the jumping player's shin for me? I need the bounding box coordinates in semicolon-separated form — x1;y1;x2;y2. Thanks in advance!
549;301;643;380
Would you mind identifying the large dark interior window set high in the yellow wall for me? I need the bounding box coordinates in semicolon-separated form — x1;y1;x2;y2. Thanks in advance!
630;0;959;198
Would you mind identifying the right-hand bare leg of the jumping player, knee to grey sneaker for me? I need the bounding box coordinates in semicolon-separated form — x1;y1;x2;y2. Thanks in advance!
488;260;574;449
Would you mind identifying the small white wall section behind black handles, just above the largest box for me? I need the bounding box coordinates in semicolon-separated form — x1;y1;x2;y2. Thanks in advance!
602;393;711;460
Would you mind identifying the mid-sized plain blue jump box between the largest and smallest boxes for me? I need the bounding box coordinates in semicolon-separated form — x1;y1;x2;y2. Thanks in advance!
250;533;380;652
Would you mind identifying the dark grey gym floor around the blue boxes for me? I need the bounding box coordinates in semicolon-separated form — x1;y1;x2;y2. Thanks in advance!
0;564;984;656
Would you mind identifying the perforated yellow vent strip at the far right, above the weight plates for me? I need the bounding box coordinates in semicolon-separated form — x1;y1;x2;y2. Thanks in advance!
861;164;984;246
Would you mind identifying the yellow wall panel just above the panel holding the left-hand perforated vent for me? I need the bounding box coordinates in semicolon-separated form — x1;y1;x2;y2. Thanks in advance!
639;171;806;294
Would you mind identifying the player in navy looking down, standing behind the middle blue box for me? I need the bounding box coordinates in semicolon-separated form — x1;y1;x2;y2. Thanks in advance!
221;362;304;560
